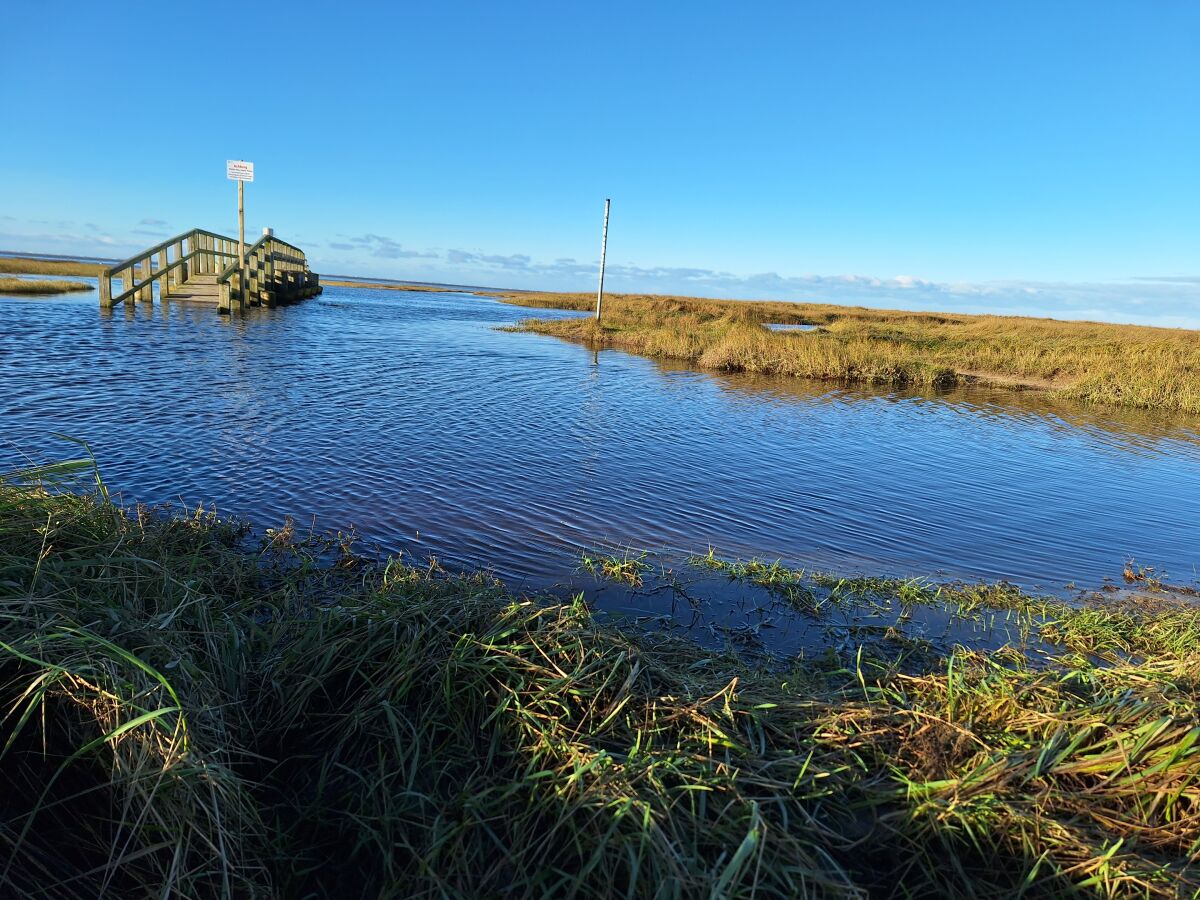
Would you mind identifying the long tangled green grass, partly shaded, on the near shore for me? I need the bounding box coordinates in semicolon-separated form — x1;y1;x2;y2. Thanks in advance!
0;466;1200;898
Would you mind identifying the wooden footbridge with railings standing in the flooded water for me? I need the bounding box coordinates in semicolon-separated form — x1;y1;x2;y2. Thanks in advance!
100;228;320;312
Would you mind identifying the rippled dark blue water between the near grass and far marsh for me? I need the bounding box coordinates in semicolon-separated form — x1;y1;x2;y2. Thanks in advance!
0;282;1200;588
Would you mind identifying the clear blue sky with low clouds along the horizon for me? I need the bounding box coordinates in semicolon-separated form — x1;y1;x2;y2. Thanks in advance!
0;0;1200;326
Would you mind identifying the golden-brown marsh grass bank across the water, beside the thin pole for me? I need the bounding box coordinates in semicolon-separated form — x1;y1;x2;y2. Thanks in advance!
504;294;1200;413
